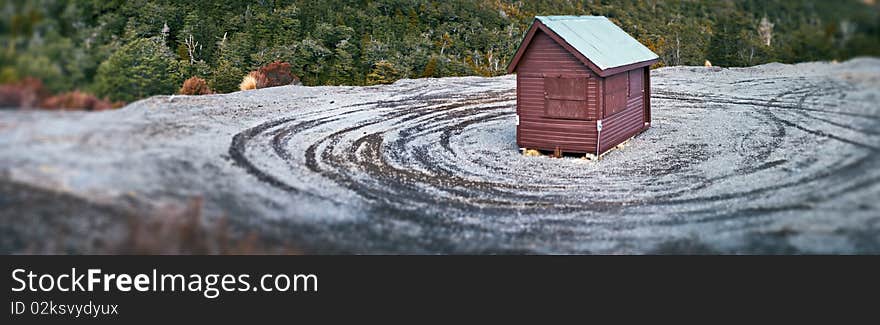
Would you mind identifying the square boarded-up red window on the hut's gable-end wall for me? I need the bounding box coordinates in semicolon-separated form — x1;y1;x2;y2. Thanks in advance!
544;75;590;119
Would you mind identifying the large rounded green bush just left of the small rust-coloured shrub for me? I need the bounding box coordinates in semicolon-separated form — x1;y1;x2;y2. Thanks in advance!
95;37;182;102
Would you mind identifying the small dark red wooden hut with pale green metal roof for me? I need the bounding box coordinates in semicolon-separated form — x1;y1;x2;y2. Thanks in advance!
507;16;658;155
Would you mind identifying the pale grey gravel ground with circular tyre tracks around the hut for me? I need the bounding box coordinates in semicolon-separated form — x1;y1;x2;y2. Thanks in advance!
0;59;880;253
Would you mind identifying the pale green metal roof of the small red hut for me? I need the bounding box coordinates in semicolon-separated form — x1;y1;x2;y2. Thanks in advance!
535;16;658;70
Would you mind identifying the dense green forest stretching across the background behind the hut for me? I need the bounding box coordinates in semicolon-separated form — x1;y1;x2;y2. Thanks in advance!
0;0;880;100
